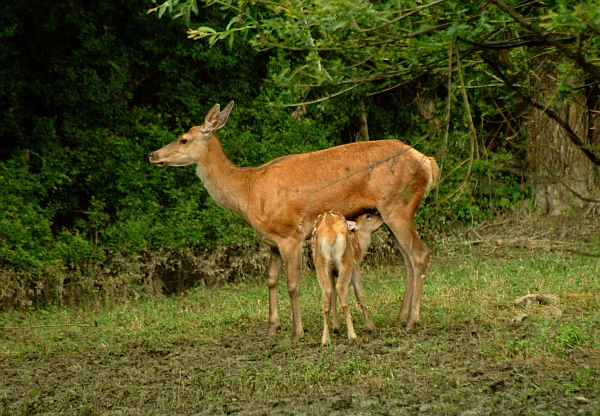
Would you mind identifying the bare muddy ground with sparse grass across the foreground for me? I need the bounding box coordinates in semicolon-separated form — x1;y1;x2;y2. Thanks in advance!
0;216;600;416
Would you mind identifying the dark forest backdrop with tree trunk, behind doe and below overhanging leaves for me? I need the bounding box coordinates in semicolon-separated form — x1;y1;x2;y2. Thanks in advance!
0;0;600;309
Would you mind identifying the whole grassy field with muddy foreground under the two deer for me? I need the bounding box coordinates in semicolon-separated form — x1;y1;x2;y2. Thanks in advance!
0;216;600;415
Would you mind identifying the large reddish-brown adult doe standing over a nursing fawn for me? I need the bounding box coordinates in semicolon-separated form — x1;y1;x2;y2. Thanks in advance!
149;101;438;340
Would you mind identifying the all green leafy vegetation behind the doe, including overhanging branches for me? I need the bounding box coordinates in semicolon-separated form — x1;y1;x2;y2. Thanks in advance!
0;0;600;310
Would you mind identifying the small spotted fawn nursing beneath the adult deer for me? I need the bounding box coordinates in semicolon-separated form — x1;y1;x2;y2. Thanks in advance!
311;211;383;345
